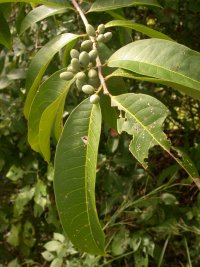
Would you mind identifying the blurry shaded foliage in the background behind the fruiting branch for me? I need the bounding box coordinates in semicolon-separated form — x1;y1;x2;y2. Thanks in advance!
0;0;200;267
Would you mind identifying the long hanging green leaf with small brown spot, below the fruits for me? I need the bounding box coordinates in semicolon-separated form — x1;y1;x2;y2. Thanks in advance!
54;99;104;255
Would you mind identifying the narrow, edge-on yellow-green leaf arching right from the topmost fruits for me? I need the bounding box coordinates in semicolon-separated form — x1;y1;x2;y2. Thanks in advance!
105;20;173;41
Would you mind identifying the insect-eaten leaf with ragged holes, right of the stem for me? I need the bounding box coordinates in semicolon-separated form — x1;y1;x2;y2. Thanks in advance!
111;93;198;184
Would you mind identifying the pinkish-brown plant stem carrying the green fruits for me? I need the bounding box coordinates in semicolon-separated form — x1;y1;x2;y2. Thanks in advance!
72;0;110;95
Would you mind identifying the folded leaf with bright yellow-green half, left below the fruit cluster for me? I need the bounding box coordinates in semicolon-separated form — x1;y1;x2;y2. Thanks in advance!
28;70;73;162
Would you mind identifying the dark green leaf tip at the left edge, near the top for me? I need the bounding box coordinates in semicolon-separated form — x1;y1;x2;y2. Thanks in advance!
0;11;12;49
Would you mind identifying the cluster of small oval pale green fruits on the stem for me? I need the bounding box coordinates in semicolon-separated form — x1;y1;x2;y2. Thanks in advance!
60;24;112;104
